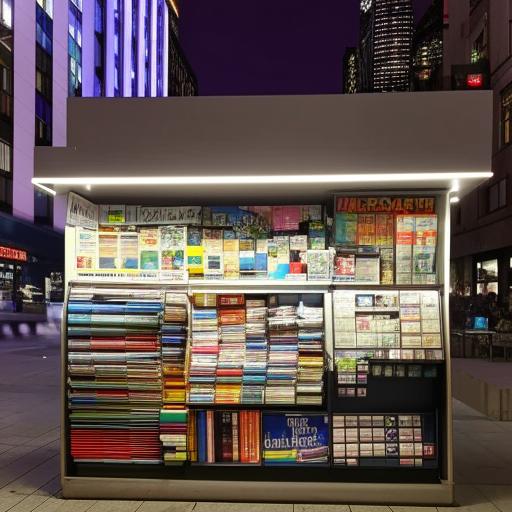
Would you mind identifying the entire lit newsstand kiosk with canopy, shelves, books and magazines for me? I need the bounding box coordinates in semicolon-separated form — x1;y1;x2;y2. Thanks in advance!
33;92;492;505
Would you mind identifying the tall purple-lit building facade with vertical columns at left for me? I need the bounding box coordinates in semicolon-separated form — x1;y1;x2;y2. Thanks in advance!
0;0;196;308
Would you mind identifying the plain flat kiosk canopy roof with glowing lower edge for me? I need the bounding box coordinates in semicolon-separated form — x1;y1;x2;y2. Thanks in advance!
33;91;492;204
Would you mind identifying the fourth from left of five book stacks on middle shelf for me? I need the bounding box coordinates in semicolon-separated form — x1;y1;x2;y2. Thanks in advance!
265;306;299;404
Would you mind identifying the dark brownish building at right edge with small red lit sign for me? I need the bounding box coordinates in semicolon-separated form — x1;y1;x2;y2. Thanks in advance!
444;0;512;306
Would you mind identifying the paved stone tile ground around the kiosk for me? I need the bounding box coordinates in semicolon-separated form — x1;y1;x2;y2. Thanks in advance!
0;328;512;512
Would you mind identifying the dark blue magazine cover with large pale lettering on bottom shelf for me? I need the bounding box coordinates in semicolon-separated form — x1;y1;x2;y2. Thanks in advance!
263;412;329;465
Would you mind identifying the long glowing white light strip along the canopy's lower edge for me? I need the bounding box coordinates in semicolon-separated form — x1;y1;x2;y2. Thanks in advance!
32;171;493;185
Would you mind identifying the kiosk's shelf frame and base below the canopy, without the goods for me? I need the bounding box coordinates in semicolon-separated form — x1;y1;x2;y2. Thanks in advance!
62;191;453;504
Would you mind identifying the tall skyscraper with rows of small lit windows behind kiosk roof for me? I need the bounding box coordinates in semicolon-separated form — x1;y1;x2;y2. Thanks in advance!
359;0;414;92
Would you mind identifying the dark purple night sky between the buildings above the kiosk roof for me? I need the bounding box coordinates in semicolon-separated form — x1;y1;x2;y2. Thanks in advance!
180;0;432;96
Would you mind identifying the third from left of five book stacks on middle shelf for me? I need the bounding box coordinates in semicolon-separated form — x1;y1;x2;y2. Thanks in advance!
242;299;268;404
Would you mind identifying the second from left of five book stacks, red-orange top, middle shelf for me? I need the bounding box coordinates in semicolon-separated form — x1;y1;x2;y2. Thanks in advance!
215;307;245;404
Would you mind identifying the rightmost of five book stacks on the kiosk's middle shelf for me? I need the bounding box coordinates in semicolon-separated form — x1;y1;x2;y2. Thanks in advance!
297;306;324;405
